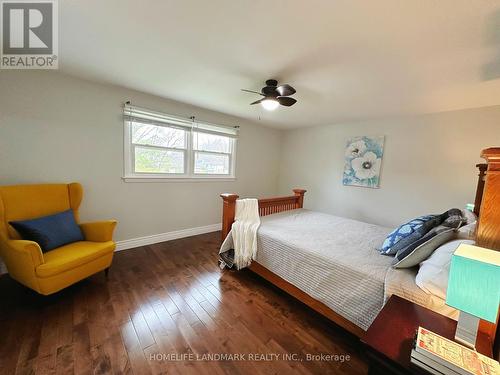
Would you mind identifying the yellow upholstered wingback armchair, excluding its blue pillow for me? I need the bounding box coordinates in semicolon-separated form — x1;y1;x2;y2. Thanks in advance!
0;183;116;295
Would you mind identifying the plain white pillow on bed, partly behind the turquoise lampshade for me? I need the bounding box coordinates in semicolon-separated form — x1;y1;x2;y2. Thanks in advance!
415;239;474;299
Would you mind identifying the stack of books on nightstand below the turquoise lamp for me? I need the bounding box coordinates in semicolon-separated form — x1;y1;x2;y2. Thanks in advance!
411;327;500;375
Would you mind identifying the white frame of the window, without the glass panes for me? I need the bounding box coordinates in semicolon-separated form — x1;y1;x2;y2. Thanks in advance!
122;106;238;182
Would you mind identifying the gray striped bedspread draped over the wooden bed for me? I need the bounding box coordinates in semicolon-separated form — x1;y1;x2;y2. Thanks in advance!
256;209;392;330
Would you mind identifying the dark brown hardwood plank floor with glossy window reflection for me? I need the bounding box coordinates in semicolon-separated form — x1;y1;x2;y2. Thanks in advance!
0;232;367;375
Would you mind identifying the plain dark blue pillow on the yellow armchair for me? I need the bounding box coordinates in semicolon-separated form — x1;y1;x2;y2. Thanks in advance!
9;210;84;252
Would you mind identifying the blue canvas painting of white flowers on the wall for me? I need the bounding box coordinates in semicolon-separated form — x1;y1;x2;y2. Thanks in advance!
343;136;384;188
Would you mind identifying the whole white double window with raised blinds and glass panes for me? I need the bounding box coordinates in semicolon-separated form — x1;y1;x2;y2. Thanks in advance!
124;105;238;179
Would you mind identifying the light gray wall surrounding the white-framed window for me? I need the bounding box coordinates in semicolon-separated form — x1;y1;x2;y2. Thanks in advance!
0;71;281;240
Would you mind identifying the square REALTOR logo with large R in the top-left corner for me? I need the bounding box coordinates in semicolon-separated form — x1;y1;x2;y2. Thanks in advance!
0;0;58;69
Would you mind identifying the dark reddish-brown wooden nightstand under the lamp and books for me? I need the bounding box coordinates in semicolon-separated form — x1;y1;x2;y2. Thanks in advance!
362;295;492;374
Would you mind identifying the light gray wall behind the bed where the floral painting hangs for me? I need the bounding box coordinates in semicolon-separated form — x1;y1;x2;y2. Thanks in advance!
280;106;500;226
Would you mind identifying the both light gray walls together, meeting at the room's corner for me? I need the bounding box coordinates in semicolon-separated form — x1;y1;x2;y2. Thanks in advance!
0;71;500;244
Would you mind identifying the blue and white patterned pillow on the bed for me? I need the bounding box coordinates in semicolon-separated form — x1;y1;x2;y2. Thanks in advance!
379;215;440;255
